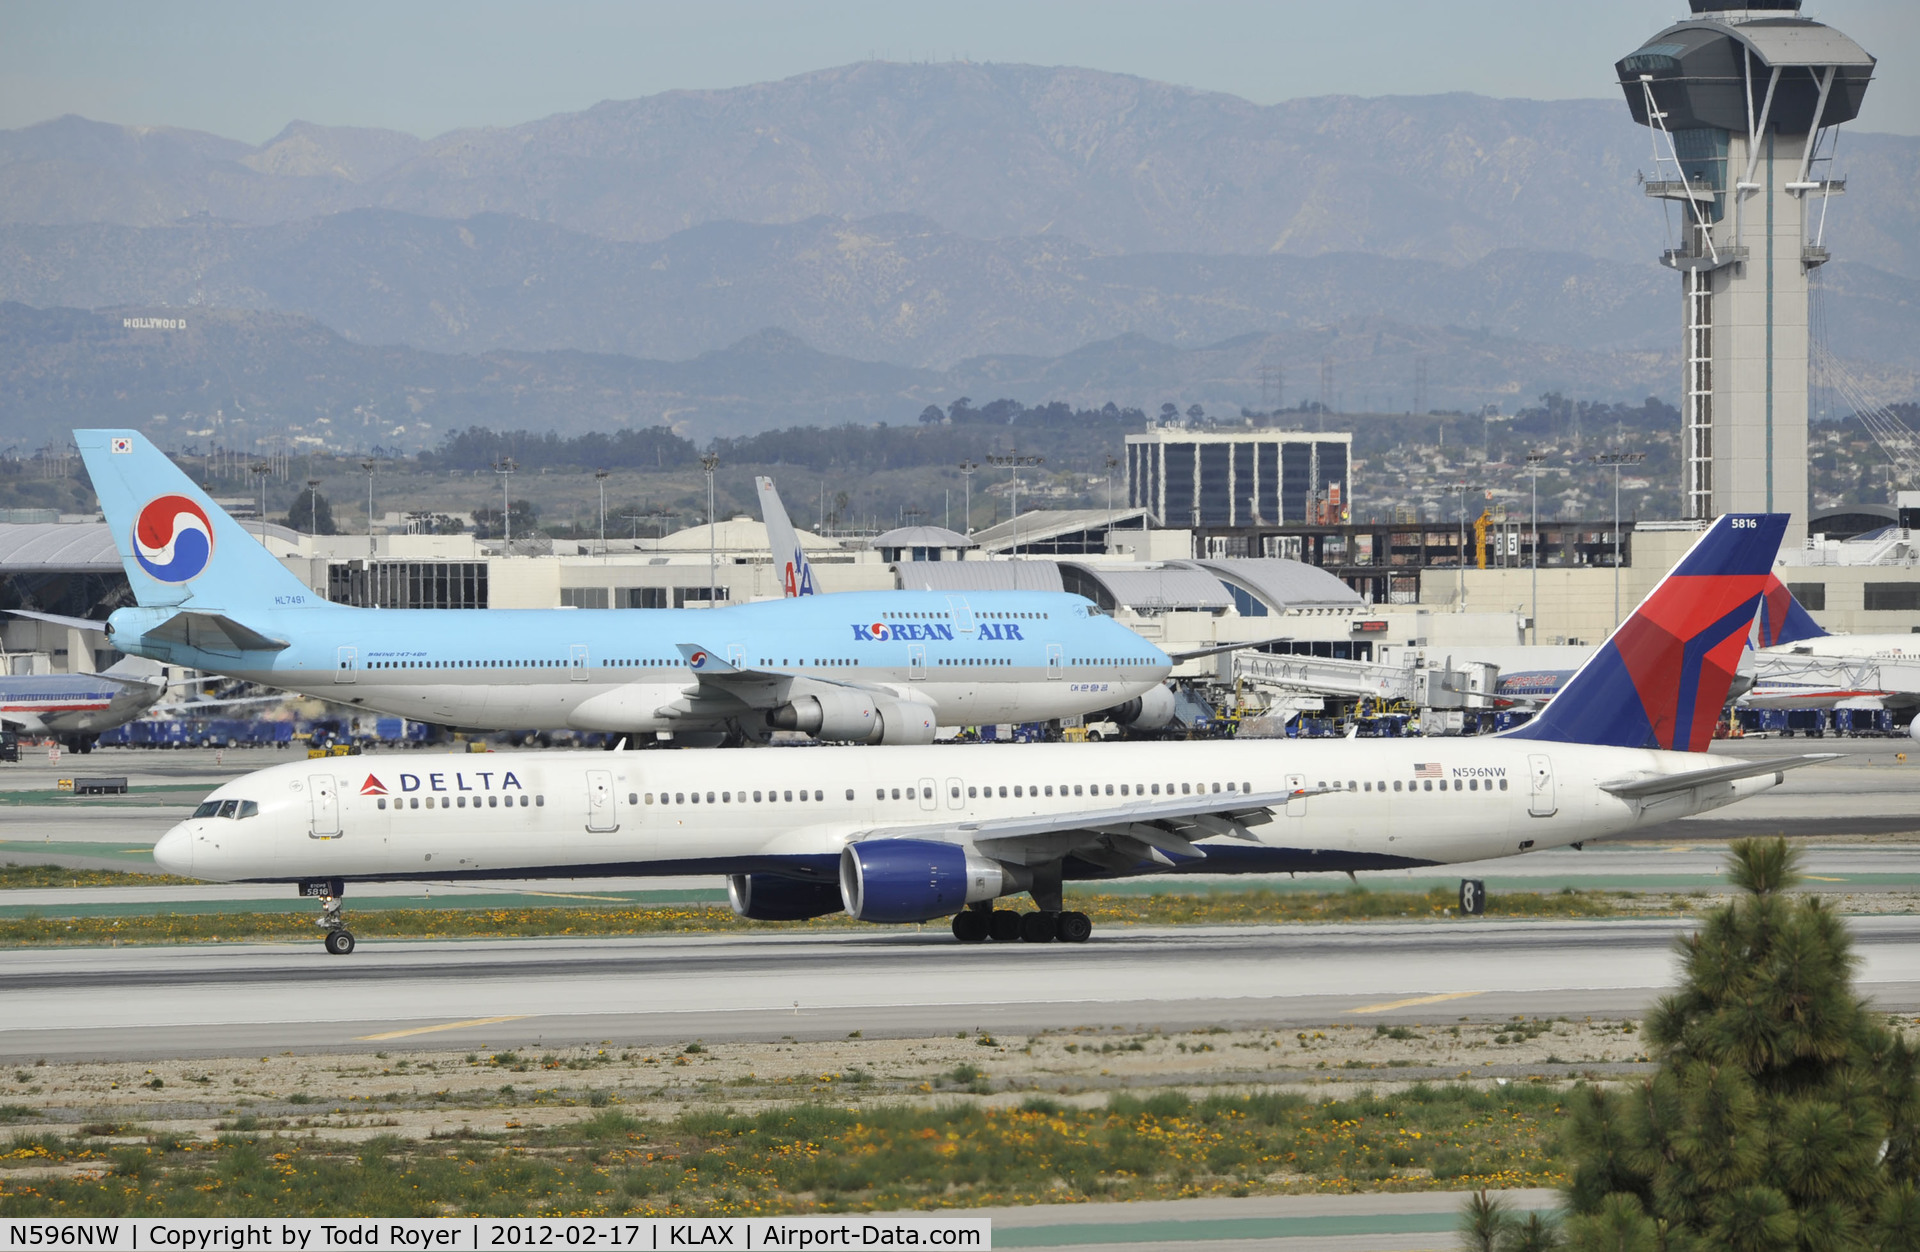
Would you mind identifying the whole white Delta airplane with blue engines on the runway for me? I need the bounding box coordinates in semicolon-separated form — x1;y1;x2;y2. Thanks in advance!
154;515;1830;954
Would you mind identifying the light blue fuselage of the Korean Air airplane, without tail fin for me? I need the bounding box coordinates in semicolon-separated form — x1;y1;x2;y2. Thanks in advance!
111;591;1171;739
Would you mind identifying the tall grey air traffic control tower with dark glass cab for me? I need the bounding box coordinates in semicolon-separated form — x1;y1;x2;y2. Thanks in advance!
1615;0;1874;547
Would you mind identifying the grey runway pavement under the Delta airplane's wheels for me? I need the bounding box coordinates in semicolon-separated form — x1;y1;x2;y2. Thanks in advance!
0;914;1920;1060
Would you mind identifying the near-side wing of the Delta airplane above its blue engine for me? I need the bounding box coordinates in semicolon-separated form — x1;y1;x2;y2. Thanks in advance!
852;787;1332;870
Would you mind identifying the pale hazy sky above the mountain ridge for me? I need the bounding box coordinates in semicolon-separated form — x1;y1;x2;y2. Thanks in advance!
0;0;1920;142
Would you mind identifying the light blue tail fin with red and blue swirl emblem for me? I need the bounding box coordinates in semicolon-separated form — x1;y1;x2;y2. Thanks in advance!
73;430;324;611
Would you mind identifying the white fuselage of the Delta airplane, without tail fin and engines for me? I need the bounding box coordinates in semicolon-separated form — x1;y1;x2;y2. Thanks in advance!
154;737;1778;894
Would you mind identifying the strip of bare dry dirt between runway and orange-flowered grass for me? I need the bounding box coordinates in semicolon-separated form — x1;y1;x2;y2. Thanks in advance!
0;1018;1666;1141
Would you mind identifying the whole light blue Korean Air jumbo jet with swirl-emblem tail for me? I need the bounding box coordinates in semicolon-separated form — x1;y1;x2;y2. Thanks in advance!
61;430;1173;743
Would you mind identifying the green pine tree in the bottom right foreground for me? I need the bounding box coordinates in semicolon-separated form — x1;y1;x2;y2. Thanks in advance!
1565;839;1920;1252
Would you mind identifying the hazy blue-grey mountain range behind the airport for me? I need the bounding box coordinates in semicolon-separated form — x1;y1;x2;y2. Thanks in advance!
0;61;1920;442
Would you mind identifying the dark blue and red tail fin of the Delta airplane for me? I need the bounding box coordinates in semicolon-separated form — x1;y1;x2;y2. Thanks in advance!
1509;513;1788;753
